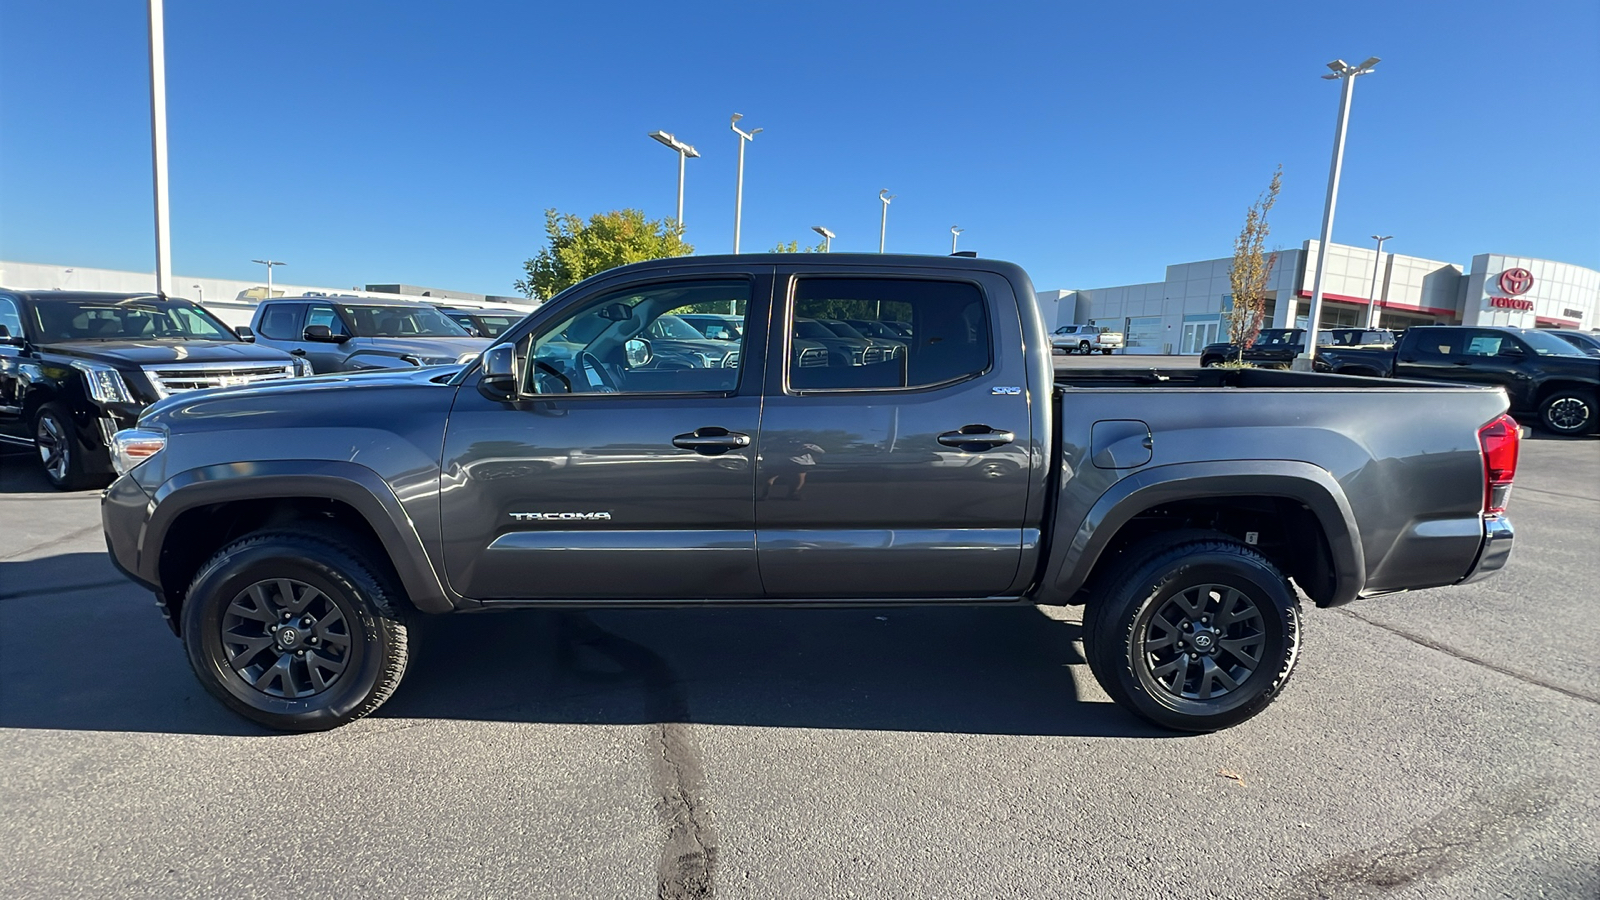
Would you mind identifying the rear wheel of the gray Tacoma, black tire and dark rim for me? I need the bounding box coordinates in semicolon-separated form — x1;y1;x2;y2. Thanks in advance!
1083;532;1299;732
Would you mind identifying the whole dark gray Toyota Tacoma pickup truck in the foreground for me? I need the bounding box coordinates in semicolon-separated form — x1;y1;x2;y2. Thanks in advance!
102;253;1518;730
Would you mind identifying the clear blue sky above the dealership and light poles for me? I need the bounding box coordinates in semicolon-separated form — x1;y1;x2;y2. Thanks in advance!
0;0;1600;293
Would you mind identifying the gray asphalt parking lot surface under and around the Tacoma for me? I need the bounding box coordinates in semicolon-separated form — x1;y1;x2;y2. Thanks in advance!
0;393;1600;898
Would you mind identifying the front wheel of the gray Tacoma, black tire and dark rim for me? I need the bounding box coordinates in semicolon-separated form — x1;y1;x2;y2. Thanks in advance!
181;530;411;732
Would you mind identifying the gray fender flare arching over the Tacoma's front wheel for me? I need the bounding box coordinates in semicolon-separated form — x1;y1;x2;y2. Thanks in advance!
138;460;456;612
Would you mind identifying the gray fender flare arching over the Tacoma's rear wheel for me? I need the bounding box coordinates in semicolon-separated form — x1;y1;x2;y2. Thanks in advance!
1043;460;1366;605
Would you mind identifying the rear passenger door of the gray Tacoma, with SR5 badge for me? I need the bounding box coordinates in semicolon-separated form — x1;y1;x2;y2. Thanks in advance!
755;272;1030;599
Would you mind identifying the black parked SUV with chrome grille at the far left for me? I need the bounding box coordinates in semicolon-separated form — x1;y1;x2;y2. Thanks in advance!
0;290;310;490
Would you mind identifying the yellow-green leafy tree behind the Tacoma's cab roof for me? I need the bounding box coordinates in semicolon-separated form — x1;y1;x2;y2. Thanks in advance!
515;210;694;299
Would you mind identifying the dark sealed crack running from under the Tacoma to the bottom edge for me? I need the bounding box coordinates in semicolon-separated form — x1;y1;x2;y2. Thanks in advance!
560;612;717;900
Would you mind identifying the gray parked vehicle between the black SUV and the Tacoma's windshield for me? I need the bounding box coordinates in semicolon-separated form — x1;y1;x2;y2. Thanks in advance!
251;296;490;375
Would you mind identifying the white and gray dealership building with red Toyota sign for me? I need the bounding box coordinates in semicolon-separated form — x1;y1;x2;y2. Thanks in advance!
1040;240;1600;354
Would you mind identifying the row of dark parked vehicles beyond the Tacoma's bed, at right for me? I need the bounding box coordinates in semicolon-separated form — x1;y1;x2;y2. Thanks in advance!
1200;325;1600;436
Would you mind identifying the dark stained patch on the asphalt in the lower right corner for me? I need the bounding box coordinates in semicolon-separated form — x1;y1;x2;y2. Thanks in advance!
1278;781;1558;900
